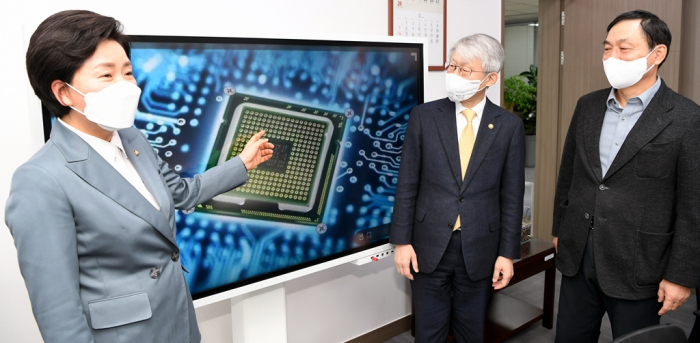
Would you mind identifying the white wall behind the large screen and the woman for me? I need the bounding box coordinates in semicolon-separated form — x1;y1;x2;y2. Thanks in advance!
0;0;501;343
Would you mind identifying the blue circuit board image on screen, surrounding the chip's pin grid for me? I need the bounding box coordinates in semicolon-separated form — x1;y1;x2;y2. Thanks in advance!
131;36;423;299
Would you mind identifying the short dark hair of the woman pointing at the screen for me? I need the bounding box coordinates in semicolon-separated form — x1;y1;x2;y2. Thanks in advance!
26;10;131;118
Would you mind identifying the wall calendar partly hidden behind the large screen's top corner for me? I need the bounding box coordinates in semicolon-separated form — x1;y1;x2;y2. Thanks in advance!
389;0;447;71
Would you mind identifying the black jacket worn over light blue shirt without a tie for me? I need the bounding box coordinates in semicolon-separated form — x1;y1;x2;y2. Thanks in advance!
552;81;700;300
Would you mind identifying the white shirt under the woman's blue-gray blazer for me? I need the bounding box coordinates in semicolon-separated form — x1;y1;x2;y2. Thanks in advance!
56;118;161;210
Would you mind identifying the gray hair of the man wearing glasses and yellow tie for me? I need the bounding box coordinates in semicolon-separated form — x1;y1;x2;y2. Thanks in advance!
449;33;505;73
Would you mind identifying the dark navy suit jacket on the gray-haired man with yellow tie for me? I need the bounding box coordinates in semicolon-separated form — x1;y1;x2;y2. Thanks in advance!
389;98;525;281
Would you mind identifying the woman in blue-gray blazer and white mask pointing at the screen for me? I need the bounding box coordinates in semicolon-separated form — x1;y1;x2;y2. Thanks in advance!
5;11;273;342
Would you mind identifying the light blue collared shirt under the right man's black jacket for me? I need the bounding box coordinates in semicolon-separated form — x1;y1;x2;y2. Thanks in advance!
599;76;661;176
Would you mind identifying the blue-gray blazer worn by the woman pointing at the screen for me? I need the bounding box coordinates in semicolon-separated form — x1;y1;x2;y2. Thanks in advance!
5;124;248;343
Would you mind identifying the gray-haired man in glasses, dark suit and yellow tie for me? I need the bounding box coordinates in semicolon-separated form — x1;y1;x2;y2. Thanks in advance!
389;34;525;342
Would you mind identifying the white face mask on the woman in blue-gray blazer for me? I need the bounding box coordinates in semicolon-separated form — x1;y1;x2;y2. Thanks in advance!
66;81;141;131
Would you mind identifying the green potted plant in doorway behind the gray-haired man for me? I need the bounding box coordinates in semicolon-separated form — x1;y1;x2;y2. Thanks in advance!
503;65;537;167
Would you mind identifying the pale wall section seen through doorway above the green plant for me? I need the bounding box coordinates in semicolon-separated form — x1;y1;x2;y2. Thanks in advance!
503;24;537;78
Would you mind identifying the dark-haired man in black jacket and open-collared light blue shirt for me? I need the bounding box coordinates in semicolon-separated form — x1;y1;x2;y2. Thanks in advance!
552;11;700;343
